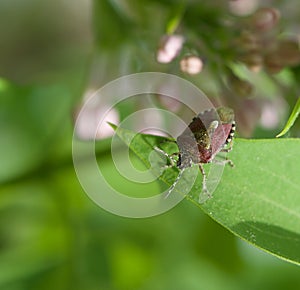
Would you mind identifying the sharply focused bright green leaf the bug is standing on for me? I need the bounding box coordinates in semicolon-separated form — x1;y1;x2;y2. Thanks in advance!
111;124;300;264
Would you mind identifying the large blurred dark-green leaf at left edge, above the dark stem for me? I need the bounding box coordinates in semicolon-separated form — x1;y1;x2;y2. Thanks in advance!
0;80;72;182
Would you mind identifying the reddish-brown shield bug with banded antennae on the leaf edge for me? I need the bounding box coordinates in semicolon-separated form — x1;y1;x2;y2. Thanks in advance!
155;107;235;202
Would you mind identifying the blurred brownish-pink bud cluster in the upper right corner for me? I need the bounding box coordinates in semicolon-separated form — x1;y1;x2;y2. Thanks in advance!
234;8;300;73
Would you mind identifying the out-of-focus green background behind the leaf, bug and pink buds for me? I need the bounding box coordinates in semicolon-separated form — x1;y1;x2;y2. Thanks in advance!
0;0;300;290
